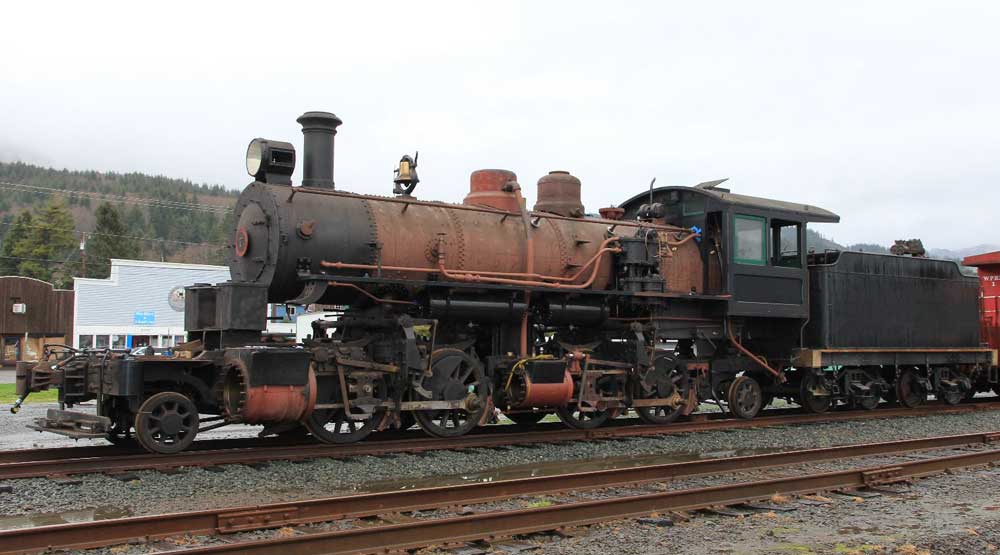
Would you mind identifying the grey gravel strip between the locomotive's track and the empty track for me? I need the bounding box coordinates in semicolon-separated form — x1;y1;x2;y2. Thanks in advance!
0;411;1000;528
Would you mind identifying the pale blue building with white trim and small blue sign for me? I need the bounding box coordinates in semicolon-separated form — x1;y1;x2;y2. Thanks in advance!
73;260;229;348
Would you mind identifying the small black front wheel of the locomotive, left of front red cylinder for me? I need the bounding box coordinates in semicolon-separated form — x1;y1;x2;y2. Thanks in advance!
135;391;198;454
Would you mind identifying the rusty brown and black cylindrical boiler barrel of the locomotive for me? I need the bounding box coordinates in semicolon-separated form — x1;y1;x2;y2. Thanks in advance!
230;183;612;304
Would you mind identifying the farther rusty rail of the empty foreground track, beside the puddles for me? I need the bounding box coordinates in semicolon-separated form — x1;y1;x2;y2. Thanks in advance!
0;433;1000;555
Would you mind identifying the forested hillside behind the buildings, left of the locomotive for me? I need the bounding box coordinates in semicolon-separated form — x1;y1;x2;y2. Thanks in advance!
0;162;239;285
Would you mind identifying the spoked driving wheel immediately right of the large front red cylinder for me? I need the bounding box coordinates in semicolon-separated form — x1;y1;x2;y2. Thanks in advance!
305;372;386;444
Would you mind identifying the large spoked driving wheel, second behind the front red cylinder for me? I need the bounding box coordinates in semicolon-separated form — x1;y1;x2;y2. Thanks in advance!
413;349;488;437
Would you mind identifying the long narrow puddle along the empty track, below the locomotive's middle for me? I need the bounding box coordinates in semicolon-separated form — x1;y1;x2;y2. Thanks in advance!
354;448;782;493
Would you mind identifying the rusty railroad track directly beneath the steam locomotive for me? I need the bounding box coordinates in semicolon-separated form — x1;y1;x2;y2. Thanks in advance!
0;402;1000;480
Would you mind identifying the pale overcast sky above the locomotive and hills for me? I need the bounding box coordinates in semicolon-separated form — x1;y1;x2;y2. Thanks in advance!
0;1;1000;248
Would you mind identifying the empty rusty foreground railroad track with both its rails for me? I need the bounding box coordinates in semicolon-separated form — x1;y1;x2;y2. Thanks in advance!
0;433;1000;555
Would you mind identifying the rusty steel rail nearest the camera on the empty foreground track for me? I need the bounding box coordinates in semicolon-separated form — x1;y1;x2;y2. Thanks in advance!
158;450;1000;555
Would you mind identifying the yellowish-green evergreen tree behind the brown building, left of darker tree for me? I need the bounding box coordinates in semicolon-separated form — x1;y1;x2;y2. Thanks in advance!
13;198;78;287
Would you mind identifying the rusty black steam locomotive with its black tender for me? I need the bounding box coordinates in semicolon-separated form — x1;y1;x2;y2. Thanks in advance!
15;112;998;453
